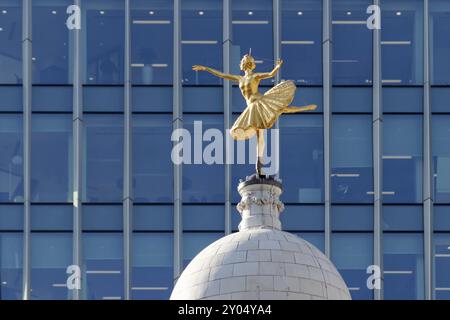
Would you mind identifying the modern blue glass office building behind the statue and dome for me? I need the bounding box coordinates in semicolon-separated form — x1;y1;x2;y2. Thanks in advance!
0;0;450;299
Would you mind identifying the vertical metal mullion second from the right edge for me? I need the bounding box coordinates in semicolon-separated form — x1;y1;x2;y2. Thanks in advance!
372;0;383;300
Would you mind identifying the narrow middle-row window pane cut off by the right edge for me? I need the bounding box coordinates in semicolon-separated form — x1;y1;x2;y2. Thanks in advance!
431;115;450;203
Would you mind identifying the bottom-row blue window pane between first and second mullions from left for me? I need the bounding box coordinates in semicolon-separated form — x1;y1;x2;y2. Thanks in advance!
31;233;72;300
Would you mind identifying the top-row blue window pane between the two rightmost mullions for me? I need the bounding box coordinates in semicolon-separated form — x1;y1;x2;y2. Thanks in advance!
381;0;423;85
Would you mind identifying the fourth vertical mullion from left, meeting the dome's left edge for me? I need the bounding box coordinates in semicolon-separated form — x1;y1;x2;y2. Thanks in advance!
172;0;183;281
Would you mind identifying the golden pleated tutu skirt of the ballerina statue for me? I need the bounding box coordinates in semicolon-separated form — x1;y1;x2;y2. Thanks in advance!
230;81;297;140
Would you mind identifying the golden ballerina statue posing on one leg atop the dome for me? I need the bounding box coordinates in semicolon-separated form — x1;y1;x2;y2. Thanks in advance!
192;53;317;176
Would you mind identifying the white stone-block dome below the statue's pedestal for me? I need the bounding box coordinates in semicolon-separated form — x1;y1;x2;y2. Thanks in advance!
170;229;351;300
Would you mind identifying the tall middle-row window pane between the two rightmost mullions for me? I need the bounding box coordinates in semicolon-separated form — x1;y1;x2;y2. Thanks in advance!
383;115;422;203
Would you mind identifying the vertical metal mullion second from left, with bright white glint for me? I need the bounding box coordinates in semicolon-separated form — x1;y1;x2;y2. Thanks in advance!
71;0;84;300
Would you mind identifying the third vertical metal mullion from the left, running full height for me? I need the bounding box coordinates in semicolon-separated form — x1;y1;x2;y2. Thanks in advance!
123;0;133;300
